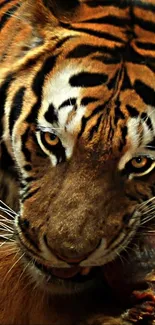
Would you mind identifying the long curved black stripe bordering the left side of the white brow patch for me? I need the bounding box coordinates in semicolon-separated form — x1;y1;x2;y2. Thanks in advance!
26;55;57;123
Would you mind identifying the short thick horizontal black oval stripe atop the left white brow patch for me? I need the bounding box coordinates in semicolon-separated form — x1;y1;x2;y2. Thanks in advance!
69;72;108;87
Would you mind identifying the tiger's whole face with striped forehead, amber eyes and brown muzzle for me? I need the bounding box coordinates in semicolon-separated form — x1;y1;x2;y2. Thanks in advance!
2;1;155;292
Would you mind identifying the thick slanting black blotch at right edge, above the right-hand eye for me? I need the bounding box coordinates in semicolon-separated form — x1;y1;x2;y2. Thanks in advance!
134;80;155;106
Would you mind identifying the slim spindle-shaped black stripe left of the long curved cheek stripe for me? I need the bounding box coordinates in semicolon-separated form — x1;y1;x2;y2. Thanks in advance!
9;87;26;134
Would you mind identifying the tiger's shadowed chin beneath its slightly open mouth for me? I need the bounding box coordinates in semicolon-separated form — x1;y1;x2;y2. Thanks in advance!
24;261;103;295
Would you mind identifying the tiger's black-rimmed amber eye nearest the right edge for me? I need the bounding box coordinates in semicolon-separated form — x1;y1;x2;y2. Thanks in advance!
125;156;155;176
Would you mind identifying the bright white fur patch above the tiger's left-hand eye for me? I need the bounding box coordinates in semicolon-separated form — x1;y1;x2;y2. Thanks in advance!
38;64;86;165
